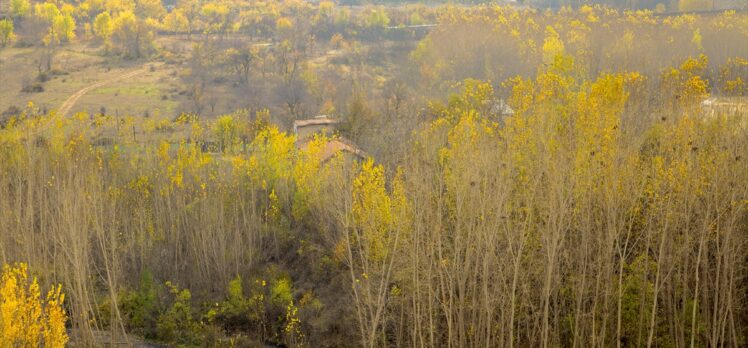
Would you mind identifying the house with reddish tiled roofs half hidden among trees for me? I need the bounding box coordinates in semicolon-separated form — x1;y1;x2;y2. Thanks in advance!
293;115;368;162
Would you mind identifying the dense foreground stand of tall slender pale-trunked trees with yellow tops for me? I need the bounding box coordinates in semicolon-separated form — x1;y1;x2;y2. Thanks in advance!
0;1;748;347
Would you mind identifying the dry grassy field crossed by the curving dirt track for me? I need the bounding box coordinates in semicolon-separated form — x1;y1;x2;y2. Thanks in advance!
0;43;185;116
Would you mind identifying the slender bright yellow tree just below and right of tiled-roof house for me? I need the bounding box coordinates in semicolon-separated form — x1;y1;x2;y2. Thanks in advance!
341;160;410;347
